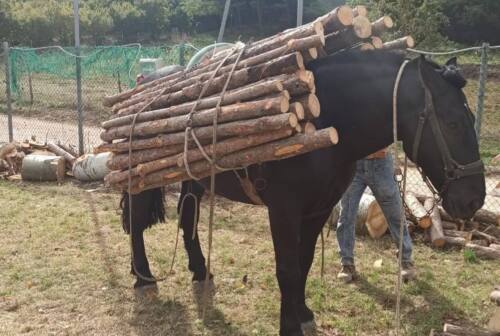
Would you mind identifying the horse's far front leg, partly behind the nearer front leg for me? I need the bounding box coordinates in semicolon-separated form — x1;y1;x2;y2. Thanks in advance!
298;211;331;323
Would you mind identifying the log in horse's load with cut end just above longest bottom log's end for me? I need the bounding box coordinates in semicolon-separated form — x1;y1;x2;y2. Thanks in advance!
97;113;298;152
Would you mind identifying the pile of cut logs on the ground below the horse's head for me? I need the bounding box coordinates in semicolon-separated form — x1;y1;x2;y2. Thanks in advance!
405;192;500;259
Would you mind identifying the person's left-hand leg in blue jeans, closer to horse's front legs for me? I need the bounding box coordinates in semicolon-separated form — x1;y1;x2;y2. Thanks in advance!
336;161;366;266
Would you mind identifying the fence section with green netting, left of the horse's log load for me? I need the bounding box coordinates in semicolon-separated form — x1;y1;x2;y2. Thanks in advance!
0;44;195;152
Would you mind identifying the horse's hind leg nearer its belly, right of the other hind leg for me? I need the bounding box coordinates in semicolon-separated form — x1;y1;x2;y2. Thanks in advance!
177;181;207;281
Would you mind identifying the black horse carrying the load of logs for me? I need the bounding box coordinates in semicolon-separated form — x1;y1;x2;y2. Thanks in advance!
120;51;485;335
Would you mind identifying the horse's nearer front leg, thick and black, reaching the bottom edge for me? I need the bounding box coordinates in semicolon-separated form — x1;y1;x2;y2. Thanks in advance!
269;207;303;336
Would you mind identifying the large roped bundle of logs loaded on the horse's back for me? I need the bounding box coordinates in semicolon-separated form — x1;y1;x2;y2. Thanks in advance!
95;6;414;193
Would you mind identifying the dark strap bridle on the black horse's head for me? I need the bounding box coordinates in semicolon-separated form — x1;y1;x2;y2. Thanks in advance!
411;58;484;196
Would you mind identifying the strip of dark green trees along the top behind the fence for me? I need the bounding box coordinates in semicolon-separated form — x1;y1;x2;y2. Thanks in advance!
0;0;500;47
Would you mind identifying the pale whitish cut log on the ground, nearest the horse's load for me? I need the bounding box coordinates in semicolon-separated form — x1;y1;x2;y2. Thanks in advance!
72;153;111;182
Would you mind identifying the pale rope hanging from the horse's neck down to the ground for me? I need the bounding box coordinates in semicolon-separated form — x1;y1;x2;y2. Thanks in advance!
392;60;410;336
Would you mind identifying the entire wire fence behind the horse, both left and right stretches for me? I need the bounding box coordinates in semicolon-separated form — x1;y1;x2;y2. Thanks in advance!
0;44;500;212
